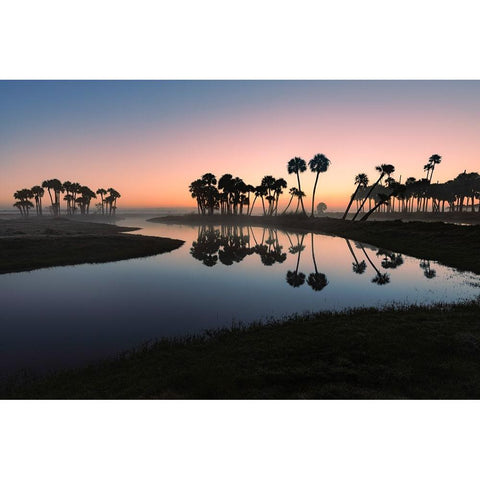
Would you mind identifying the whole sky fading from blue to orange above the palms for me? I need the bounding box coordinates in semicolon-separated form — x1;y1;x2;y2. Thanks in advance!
0;80;480;210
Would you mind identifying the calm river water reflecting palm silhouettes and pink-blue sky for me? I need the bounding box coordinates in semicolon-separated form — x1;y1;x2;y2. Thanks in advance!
0;218;480;373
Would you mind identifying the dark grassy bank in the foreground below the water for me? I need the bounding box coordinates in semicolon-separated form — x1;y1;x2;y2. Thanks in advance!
2;302;480;399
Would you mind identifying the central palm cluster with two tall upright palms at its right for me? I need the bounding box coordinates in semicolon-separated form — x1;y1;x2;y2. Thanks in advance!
189;153;330;217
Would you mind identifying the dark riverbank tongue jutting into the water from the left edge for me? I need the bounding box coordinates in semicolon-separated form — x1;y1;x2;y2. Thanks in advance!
0;217;184;274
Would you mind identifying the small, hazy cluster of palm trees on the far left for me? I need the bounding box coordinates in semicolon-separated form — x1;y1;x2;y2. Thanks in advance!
13;178;121;217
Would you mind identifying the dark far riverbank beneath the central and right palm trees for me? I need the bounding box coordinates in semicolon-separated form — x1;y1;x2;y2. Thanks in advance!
149;215;480;274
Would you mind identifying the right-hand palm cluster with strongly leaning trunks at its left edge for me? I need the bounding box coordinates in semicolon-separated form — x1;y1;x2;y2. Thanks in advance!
343;154;480;220
